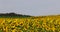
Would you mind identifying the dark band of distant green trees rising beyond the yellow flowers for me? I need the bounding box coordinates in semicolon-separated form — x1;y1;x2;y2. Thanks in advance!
0;13;31;18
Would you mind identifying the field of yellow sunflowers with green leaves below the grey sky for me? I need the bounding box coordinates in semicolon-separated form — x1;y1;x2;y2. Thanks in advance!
0;16;60;32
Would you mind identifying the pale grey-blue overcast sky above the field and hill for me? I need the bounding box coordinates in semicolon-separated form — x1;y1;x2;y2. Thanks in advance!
0;0;60;16
